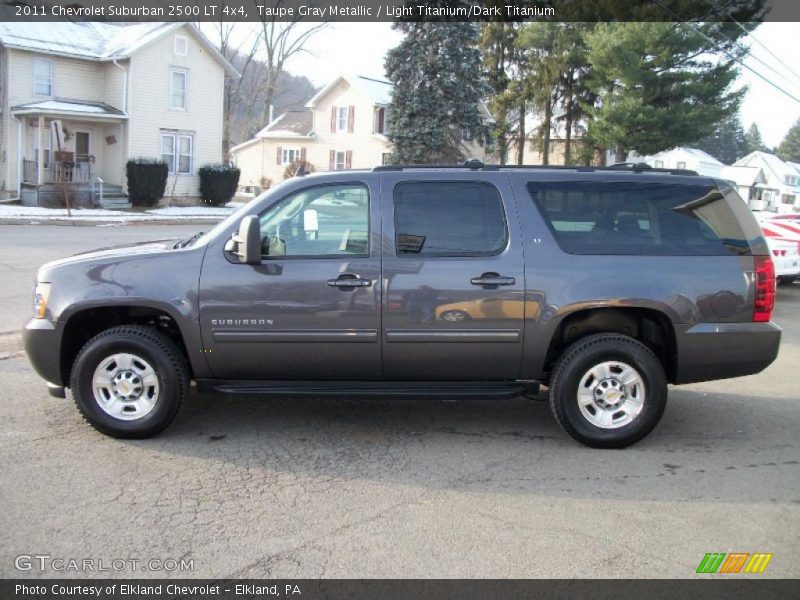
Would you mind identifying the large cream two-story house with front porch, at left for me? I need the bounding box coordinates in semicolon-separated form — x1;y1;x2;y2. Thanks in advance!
0;22;238;204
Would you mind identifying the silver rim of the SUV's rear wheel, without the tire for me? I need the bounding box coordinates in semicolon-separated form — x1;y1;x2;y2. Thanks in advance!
578;360;645;429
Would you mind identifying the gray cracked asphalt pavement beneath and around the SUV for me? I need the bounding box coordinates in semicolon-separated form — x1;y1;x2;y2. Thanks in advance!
0;226;800;578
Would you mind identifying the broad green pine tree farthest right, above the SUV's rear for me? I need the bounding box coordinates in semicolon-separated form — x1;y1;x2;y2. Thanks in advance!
586;22;746;154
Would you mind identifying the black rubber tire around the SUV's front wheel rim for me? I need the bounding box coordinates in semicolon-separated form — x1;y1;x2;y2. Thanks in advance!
70;325;189;439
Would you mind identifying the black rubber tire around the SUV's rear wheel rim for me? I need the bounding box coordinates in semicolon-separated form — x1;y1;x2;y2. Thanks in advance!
550;334;667;448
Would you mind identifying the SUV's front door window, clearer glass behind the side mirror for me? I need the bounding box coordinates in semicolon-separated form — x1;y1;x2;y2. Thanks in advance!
260;184;369;257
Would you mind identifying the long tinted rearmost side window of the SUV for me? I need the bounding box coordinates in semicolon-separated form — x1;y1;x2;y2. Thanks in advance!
528;182;751;256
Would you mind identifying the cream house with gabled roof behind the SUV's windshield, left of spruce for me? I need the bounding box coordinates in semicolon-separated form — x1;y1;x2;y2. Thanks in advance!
230;75;492;191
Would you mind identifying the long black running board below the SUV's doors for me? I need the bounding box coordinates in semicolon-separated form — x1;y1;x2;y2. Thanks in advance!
197;379;538;399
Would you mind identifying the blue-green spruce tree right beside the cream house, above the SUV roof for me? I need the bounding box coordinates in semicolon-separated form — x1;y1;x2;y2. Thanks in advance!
386;21;488;164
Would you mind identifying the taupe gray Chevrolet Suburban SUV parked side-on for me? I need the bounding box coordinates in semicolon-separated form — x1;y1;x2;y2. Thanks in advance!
25;162;781;448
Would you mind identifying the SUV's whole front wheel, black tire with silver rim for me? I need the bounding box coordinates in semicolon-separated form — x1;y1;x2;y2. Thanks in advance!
70;325;189;438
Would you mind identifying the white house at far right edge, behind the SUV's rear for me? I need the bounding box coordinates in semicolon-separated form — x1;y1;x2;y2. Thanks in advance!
733;151;800;213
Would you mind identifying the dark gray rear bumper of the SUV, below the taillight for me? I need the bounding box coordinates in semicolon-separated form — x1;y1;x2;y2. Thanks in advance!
675;323;781;383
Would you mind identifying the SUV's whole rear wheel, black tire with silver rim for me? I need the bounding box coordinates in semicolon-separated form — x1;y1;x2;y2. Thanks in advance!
550;334;667;448
